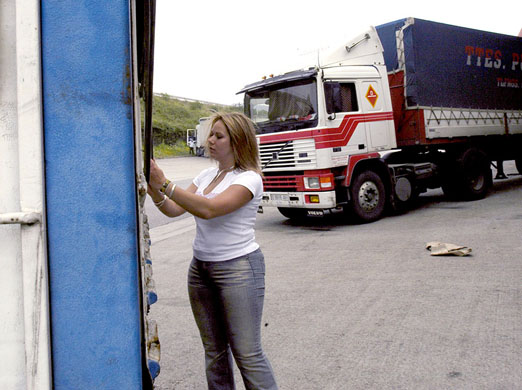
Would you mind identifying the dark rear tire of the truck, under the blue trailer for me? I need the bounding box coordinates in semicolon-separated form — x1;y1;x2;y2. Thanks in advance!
442;148;493;200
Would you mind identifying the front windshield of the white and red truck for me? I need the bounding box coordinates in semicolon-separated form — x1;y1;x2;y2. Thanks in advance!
245;78;317;134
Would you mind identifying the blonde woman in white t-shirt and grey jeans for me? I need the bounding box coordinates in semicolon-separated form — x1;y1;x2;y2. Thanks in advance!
149;113;277;390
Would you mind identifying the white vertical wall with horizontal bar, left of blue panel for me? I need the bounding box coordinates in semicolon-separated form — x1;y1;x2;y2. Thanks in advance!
0;0;51;390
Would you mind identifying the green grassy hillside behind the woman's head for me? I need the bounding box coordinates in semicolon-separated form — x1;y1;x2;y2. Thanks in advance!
146;94;243;158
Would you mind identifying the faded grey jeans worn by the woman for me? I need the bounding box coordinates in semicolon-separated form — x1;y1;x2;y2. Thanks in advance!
188;249;277;390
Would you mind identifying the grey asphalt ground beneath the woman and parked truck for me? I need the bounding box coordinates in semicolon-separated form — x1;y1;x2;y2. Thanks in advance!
146;159;522;390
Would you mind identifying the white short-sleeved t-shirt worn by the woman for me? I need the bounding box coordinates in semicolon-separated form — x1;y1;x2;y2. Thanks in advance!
192;168;263;261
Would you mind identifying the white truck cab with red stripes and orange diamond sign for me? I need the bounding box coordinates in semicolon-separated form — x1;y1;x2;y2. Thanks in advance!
240;29;396;221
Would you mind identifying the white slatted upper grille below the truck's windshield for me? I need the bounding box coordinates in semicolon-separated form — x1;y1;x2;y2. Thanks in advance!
259;138;317;171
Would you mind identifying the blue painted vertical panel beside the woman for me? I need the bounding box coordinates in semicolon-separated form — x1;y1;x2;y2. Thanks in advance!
41;0;142;390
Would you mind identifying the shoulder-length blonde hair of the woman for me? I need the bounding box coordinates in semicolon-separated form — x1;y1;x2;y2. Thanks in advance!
205;112;261;174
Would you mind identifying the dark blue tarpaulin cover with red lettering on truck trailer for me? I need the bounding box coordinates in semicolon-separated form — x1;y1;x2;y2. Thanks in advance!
376;19;522;110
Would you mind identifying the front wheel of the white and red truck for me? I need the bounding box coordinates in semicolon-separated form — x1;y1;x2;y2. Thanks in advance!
349;171;386;223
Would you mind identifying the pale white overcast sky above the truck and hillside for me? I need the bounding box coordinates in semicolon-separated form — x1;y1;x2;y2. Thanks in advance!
154;0;522;104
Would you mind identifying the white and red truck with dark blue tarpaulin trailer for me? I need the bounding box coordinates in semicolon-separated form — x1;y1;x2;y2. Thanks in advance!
238;18;522;223
